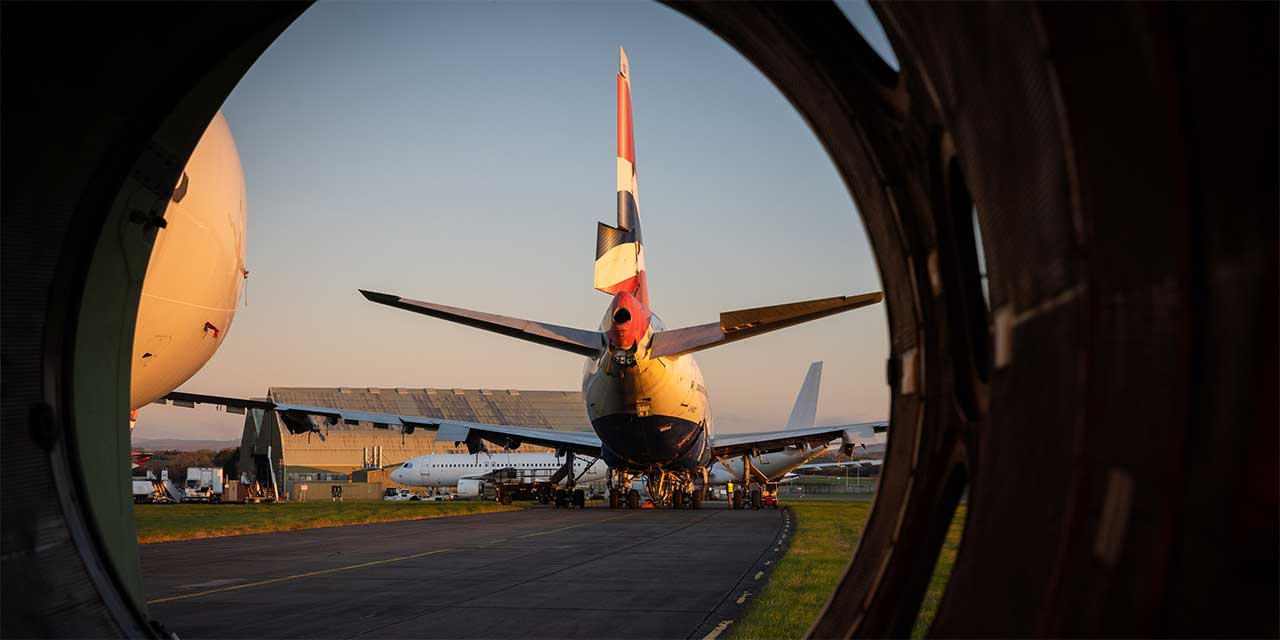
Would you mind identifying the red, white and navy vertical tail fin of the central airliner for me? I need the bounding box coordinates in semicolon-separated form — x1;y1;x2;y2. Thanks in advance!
595;47;649;307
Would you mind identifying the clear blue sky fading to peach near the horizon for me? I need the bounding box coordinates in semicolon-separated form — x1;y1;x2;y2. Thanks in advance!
133;1;896;439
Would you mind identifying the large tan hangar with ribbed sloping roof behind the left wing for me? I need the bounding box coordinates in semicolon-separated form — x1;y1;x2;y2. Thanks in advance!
239;387;591;495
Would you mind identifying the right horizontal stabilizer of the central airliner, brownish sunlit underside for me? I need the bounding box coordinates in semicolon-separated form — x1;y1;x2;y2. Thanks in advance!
649;291;884;357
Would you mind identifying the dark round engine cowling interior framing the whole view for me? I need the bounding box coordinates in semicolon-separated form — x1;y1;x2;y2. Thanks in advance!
0;3;1280;637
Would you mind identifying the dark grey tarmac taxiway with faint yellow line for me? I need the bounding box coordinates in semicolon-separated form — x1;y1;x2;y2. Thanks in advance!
138;504;791;639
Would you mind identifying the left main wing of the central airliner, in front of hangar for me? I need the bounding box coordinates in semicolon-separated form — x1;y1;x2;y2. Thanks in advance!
159;392;600;457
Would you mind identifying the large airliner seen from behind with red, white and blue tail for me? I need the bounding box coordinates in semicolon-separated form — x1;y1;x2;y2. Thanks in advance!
169;47;883;509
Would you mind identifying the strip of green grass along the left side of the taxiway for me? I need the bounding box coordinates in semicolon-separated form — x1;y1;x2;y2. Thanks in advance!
133;500;521;544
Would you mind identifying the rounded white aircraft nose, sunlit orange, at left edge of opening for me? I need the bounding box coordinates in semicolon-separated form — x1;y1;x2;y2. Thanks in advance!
129;111;248;419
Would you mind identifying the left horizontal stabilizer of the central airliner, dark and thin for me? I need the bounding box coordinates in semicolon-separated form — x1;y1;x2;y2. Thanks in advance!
360;289;604;357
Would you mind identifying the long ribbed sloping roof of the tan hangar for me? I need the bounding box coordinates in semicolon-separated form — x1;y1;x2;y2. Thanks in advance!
268;387;591;431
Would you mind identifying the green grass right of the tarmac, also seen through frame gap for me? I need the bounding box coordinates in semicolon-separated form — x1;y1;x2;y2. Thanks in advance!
730;499;964;640
